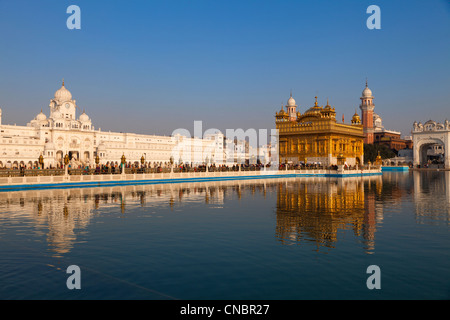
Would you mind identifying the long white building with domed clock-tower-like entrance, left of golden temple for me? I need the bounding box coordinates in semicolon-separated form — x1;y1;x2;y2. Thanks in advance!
0;81;223;167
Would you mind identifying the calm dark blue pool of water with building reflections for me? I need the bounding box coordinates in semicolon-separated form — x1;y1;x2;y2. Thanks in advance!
0;172;450;300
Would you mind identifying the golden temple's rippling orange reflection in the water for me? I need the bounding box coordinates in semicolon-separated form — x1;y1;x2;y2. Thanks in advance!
276;176;383;252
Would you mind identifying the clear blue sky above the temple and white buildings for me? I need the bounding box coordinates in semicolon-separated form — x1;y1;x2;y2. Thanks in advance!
0;0;450;135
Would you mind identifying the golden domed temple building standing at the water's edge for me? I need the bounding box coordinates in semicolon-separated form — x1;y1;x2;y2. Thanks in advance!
275;95;364;166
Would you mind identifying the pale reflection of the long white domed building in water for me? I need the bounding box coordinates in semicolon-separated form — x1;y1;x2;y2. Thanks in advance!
0;179;282;257
